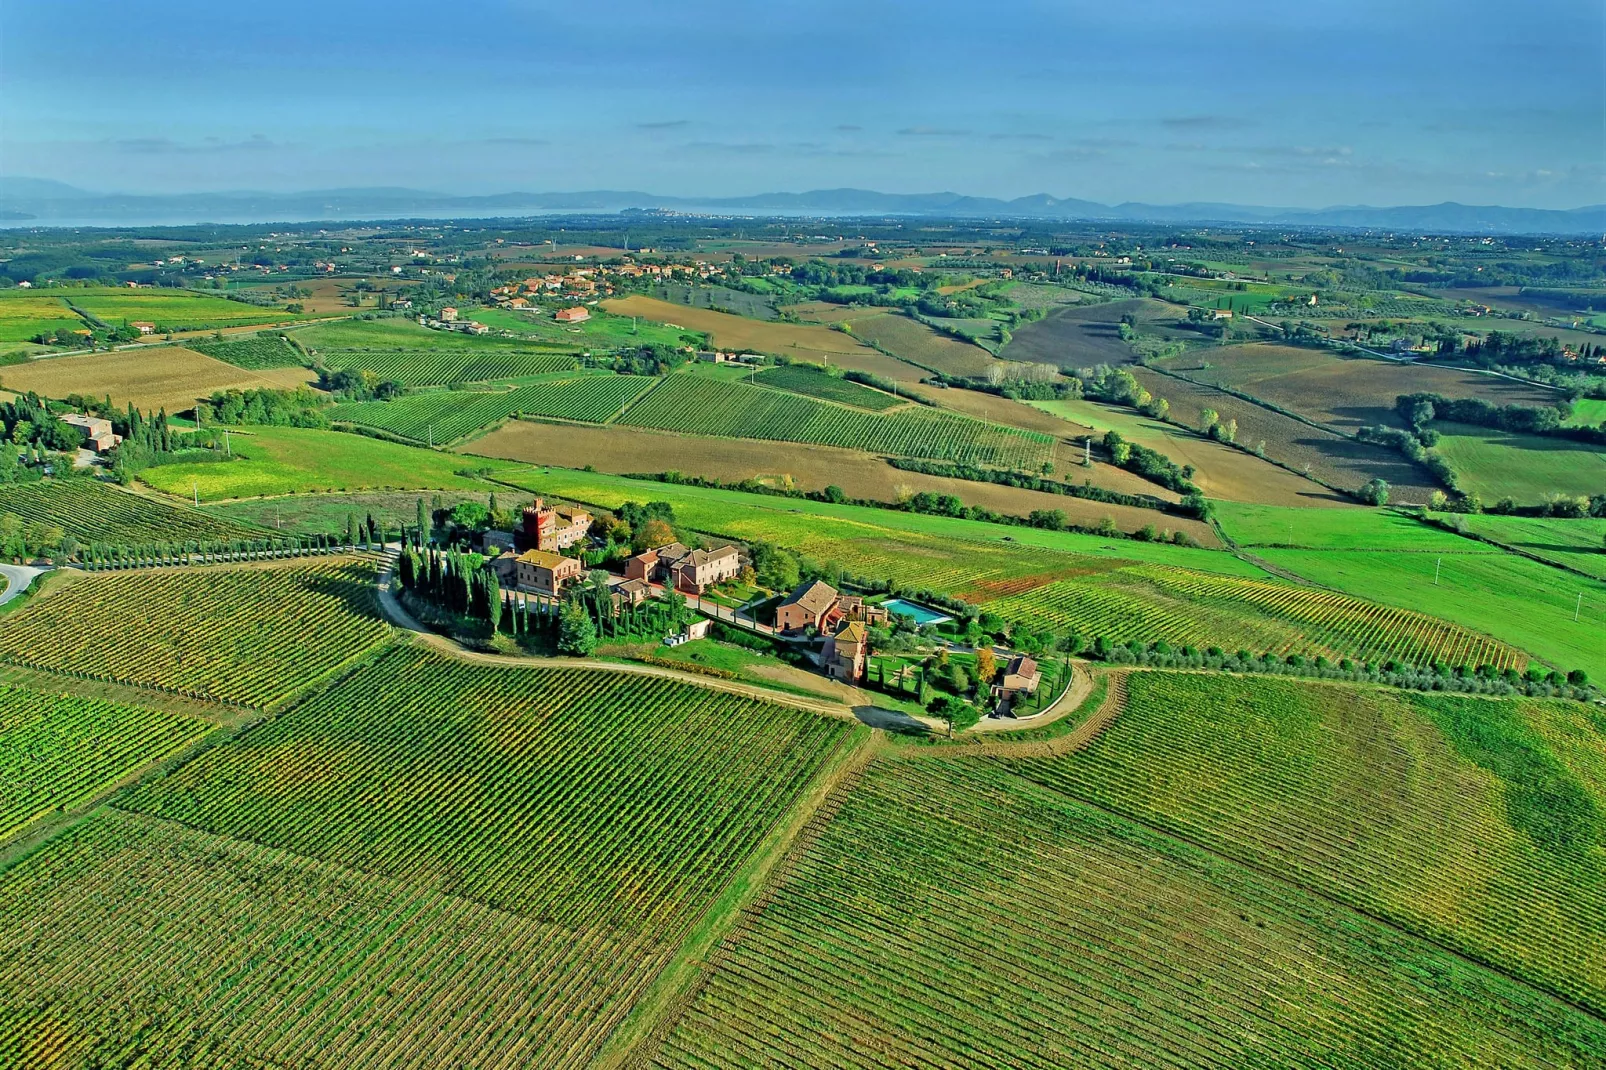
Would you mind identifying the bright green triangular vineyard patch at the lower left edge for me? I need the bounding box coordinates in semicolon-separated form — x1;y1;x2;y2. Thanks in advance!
0;684;210;837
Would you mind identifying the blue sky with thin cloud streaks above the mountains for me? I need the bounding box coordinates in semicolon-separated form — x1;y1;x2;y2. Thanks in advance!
0;0;1606;207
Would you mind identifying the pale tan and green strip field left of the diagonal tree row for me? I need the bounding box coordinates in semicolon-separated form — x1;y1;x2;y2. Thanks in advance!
1031;402;1351;506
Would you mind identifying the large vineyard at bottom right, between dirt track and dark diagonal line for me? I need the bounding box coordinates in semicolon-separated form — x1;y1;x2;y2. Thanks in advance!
632;755;1606;1070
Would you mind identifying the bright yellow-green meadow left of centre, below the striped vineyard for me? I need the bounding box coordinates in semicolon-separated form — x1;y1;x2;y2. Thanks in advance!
140;427;525;501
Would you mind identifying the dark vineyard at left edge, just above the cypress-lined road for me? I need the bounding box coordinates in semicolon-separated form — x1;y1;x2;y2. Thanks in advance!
0;479;263;545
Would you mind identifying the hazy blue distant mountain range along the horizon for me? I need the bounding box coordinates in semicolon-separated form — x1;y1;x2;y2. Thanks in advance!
0;177;1606;235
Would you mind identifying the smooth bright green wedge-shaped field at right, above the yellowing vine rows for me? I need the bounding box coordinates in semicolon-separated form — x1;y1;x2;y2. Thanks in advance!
1256;549;1606;678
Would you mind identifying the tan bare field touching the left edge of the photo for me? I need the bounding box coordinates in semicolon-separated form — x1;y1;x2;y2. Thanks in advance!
0;345;315;413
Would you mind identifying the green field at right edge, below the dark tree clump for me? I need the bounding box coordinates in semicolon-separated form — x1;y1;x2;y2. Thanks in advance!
1434;423;1606;504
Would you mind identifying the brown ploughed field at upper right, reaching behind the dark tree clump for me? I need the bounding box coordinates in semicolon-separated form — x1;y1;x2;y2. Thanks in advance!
1163;344;1561;436
